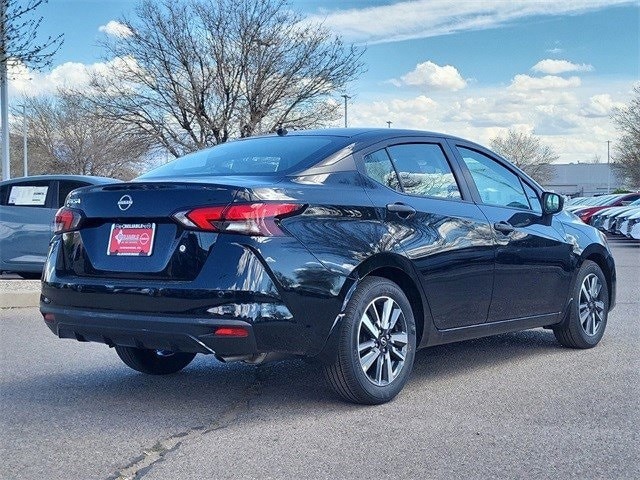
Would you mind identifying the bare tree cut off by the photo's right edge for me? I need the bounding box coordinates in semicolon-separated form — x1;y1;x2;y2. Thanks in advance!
613;85;640;189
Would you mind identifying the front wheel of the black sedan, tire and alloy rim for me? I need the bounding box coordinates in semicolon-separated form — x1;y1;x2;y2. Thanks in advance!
553;260;609;348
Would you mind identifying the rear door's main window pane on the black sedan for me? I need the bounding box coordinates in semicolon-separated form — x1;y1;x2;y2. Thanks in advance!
388;143;461;199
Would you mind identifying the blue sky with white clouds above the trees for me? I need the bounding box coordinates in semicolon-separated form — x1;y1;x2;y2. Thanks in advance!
13;0;640;162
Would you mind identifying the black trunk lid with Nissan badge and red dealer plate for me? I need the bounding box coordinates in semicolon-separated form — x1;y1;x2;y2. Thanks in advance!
62;181;251;280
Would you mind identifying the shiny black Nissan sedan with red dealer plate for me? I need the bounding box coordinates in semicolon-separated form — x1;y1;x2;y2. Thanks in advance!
40;129;616;404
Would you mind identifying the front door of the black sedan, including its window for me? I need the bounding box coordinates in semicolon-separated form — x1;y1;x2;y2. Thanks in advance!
452;142;572;322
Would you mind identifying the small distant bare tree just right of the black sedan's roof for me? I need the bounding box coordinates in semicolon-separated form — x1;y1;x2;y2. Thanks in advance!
490;130;558;183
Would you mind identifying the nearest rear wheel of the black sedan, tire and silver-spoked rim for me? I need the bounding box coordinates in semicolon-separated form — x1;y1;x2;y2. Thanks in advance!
324;276;416;405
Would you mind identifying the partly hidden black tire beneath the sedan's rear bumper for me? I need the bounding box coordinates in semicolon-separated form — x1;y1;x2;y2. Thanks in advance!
115;345;196;375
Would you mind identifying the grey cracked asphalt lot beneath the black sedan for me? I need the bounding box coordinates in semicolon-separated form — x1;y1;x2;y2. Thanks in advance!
0;240;640;479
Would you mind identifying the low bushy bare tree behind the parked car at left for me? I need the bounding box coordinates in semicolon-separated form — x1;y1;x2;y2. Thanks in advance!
17;93;150;179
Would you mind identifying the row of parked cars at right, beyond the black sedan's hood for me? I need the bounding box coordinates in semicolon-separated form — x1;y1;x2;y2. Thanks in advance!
565;193;640;240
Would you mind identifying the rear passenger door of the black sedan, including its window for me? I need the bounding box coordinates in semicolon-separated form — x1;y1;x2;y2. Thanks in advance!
363;137;494;329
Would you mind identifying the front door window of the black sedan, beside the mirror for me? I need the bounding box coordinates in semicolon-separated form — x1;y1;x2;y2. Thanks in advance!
457;147;529;210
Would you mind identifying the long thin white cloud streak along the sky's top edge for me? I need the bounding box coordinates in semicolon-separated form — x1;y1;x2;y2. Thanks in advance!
309;0;636;44
